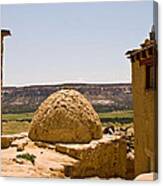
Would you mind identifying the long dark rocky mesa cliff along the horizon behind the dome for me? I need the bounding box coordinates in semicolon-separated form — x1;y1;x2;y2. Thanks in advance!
2;84;132;113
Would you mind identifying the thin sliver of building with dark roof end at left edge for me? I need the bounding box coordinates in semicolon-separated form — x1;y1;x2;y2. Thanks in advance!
1;29;11;87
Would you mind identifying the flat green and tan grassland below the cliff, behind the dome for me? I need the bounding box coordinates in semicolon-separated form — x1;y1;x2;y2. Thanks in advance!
2;110;133;134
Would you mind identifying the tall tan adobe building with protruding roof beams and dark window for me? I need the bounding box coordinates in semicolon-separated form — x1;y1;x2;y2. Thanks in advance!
126;27;158;176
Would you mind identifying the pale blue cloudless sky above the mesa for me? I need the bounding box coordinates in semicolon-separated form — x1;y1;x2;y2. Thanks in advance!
1;1;153;86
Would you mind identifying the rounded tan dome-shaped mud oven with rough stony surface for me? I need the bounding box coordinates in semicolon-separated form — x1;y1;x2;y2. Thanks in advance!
28;89;102;143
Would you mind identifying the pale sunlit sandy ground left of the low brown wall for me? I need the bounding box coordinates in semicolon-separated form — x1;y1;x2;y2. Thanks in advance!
1;136;77;178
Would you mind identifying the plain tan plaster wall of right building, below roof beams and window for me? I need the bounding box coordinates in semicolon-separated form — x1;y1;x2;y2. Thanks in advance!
132;61;156;175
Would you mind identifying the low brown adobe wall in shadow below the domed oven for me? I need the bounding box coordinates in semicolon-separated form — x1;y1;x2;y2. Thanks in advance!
56;139;131;179
